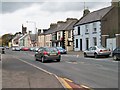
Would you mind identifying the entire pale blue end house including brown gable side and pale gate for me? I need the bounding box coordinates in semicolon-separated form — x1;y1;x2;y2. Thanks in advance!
74;2;120;51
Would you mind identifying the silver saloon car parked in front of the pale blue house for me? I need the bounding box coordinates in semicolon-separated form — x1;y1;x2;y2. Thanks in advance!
84;46;111;58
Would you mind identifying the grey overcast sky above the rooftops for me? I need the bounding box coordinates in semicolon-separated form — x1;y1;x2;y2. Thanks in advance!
0;0;111;36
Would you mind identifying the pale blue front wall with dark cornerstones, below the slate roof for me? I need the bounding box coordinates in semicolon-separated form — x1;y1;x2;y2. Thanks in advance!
74;21;101;51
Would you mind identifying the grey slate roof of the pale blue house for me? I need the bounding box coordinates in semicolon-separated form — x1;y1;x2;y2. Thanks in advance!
75;6;112;26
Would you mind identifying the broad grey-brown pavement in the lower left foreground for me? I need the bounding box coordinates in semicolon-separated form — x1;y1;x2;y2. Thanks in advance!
2;55;64;90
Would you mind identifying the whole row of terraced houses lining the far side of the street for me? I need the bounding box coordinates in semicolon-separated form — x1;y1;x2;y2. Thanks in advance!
12;2;120;51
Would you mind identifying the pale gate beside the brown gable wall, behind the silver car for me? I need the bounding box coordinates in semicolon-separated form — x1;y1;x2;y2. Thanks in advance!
106;38;116;51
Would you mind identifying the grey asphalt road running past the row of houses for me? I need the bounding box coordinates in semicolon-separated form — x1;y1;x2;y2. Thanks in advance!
0;50;119;90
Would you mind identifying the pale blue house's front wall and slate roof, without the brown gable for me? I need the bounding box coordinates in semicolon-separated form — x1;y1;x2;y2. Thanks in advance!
73;7;111;51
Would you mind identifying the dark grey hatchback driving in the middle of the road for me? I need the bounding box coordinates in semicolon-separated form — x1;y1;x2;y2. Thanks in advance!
35;47;61;63
